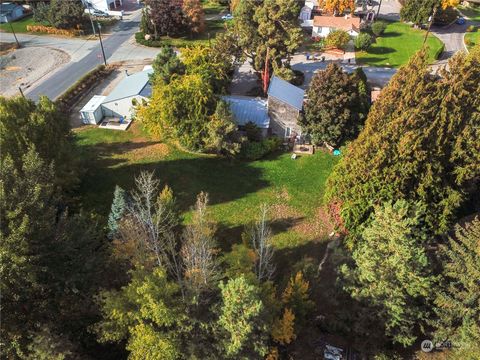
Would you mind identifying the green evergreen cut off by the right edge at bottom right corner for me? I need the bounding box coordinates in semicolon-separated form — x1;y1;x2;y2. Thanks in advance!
436;217;480;359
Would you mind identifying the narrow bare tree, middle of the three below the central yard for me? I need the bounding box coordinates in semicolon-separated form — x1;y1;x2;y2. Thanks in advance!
181;192;218;297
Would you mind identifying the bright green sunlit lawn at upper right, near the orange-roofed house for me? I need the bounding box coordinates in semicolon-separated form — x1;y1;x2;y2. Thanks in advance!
356;22;442;67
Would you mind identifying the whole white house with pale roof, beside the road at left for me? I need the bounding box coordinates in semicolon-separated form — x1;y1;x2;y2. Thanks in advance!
80;68;153;124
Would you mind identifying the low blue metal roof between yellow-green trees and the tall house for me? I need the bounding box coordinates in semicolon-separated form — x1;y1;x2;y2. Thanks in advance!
222;96;270;129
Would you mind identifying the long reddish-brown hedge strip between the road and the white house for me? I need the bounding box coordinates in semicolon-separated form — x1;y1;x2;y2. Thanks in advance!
56;65;115;110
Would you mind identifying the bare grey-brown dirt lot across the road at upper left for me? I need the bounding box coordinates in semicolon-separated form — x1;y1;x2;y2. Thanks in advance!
0;47;70;96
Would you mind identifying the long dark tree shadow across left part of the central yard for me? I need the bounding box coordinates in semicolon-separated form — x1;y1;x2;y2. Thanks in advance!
75;141;279;216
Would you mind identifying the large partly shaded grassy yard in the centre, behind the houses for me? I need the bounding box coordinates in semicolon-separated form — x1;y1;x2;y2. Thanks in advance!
77;126;337;249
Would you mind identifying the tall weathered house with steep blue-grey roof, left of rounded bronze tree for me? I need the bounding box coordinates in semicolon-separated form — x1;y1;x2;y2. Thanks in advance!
268;76;305;138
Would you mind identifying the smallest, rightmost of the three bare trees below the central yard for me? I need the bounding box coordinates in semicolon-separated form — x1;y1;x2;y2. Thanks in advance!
250;204;275;281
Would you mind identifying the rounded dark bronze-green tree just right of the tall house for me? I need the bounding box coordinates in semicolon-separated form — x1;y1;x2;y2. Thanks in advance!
299;64;368;146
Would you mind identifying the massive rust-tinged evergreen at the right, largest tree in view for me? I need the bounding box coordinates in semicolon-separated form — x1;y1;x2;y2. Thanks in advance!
326;48;480;239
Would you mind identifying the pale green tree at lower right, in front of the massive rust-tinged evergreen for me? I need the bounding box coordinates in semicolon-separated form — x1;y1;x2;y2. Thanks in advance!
341;200;435;346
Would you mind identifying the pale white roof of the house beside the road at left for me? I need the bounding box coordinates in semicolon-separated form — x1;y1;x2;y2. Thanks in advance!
103;69;153;104
